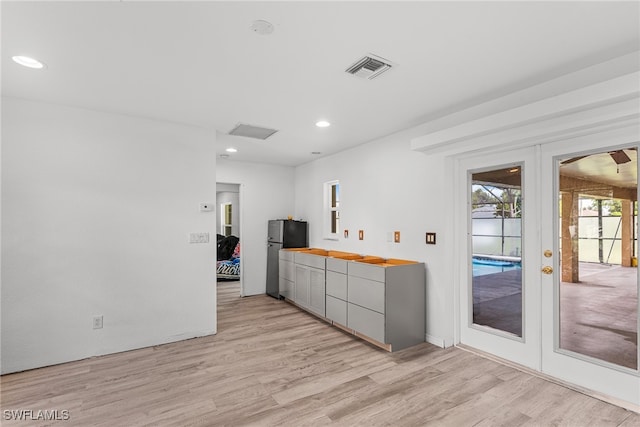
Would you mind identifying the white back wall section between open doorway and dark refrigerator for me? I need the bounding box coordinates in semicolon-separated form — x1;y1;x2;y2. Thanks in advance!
216;159;296;296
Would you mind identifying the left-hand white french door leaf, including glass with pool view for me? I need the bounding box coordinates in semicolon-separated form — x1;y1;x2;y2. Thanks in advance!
457;148;540;369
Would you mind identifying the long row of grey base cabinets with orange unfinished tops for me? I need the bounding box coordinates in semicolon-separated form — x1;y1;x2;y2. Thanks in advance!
280;249;426;351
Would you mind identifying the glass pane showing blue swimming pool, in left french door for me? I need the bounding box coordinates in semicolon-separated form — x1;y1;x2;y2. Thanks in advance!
469;166;524;337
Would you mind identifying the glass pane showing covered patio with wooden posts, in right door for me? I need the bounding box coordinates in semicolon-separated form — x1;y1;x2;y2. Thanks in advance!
558;148;638;370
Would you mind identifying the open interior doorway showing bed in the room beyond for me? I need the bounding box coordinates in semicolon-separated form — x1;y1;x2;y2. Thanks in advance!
216;182;244;297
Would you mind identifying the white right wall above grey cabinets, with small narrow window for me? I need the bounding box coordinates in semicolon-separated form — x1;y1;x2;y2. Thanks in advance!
295;132;454;345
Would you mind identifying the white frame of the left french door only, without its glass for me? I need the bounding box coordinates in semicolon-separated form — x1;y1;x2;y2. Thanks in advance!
454;147;541;370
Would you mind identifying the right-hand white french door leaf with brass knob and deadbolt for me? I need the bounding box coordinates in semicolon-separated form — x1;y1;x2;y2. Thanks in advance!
540;134;640;409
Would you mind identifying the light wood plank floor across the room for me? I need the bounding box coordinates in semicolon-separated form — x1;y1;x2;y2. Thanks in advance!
1;282;640;427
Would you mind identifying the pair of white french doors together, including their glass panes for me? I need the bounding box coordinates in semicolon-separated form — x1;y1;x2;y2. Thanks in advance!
456;134;640;407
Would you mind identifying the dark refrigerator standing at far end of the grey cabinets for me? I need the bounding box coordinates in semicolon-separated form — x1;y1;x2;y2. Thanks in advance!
267;219;309;298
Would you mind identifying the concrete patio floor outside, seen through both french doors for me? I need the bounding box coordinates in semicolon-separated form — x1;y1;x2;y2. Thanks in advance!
473;263;638;370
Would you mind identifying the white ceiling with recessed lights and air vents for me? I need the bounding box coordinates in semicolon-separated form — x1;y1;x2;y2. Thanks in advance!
1;1;640;165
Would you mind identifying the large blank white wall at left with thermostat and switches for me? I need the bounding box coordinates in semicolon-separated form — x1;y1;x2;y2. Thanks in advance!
2;98;216;373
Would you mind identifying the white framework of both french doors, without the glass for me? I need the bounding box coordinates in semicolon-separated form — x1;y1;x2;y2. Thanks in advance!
453;126;640;411
